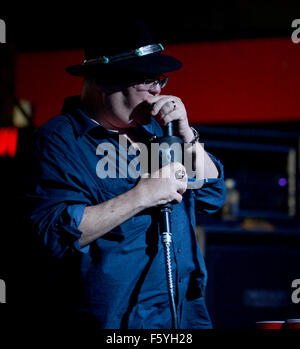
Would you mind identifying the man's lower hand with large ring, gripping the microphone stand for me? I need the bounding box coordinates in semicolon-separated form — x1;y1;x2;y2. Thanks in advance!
136;162;187;207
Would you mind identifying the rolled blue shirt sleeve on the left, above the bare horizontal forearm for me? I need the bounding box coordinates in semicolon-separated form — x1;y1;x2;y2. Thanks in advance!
27;126;91;258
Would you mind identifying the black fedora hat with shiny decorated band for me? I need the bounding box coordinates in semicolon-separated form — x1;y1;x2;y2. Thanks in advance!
66;21;182;76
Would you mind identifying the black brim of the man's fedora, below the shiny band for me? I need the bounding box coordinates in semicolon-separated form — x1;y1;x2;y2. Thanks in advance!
66;54;182;76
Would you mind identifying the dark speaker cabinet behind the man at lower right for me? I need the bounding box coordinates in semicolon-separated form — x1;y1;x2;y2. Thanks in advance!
204;230;300;329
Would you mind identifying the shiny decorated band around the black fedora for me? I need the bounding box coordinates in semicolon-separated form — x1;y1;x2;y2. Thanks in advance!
82;44;164;65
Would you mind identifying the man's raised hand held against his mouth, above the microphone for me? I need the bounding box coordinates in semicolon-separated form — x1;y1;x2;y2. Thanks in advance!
148;96;194;142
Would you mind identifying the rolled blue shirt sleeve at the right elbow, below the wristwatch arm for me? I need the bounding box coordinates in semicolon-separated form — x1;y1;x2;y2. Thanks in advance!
194;154;226;214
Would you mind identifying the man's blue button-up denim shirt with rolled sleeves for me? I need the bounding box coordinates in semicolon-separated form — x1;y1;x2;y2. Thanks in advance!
27;97;225;329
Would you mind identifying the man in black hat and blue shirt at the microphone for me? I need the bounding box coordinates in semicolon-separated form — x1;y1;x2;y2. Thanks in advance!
27;23;225;329
